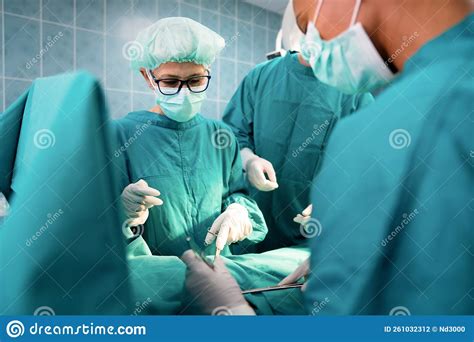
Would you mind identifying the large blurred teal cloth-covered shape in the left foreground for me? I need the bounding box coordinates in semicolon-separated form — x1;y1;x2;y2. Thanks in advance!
0;73;132;315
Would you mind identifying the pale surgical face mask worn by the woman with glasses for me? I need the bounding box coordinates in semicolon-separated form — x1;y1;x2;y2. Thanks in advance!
147;71;206;122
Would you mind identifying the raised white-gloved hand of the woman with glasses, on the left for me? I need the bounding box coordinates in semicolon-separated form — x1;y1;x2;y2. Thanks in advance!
121;179;163;227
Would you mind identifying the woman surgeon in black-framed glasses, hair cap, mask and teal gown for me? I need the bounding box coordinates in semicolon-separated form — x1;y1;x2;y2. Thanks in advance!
116;17;267;256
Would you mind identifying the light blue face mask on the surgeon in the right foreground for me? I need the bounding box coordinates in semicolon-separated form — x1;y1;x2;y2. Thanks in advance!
301;0;394;94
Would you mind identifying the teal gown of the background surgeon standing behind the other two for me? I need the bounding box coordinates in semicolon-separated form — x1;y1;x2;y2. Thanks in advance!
223;54;373;250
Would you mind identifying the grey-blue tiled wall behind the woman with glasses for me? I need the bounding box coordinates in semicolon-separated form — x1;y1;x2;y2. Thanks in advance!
0;0;281;118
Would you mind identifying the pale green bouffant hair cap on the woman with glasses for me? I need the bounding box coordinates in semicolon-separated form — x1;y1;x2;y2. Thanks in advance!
130;17;225;70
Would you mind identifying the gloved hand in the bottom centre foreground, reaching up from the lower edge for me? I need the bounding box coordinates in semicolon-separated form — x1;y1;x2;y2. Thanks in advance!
181;250;255;315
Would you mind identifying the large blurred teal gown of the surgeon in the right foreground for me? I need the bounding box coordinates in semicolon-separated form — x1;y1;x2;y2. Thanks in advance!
306;15;474;315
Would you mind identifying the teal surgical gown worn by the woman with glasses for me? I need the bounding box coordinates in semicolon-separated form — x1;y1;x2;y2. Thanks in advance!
115;111;267;256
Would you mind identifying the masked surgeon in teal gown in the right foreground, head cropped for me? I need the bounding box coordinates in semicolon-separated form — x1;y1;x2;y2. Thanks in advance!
181;0;474;315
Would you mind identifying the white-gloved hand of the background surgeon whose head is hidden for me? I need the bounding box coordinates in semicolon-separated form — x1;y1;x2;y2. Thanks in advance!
240;147;278;191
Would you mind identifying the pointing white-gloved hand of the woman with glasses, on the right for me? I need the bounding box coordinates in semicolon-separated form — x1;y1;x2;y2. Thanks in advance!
204;203;253;250
